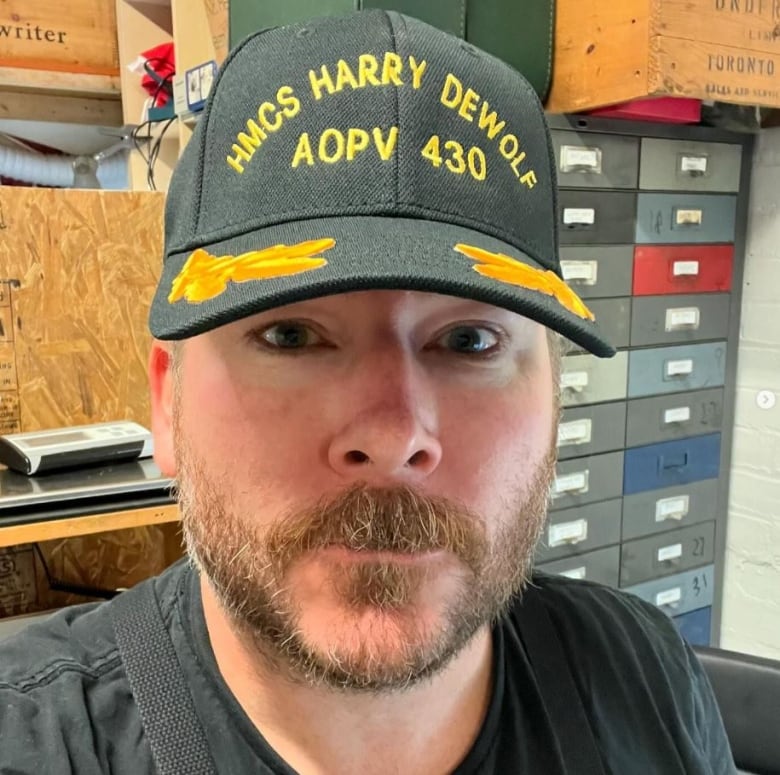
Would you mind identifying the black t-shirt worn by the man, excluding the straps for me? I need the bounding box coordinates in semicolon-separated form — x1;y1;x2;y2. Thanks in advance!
0;563;736;775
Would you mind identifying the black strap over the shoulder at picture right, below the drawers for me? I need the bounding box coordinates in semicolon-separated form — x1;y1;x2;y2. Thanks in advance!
514;586;605;775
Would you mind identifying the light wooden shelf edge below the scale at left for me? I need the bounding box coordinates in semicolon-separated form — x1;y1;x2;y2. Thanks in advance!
0;504;179;547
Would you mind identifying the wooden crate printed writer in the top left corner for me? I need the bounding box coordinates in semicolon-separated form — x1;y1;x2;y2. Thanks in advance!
0;0;119;75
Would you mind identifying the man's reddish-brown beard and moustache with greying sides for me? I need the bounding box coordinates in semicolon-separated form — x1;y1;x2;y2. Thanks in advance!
174;412;555;692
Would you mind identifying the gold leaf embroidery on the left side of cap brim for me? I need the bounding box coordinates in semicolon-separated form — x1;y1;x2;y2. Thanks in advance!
168;237;336;304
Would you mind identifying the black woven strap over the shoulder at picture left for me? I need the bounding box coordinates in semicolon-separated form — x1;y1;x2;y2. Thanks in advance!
111;581;217;775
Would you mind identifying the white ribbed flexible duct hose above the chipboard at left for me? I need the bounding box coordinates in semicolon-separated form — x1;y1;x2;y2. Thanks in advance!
0;146;127;188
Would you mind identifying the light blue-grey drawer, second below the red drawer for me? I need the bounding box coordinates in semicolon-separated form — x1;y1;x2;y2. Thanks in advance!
624;342;727;398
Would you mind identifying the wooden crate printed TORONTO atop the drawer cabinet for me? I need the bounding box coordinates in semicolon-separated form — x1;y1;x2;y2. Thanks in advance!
546;0;780;113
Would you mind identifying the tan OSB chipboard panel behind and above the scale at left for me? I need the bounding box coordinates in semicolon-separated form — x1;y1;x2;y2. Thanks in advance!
0;187;163;432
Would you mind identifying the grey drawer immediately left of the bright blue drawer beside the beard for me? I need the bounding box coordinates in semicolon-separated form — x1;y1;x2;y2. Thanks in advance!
550;452;623;511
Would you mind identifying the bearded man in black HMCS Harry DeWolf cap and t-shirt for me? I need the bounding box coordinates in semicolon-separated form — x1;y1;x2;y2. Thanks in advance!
0;11;735;775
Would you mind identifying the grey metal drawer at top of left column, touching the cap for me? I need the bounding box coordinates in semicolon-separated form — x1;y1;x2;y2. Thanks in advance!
552;130;639;188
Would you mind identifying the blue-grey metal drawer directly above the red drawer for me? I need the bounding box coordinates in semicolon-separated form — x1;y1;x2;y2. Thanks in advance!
635;192;737;245
